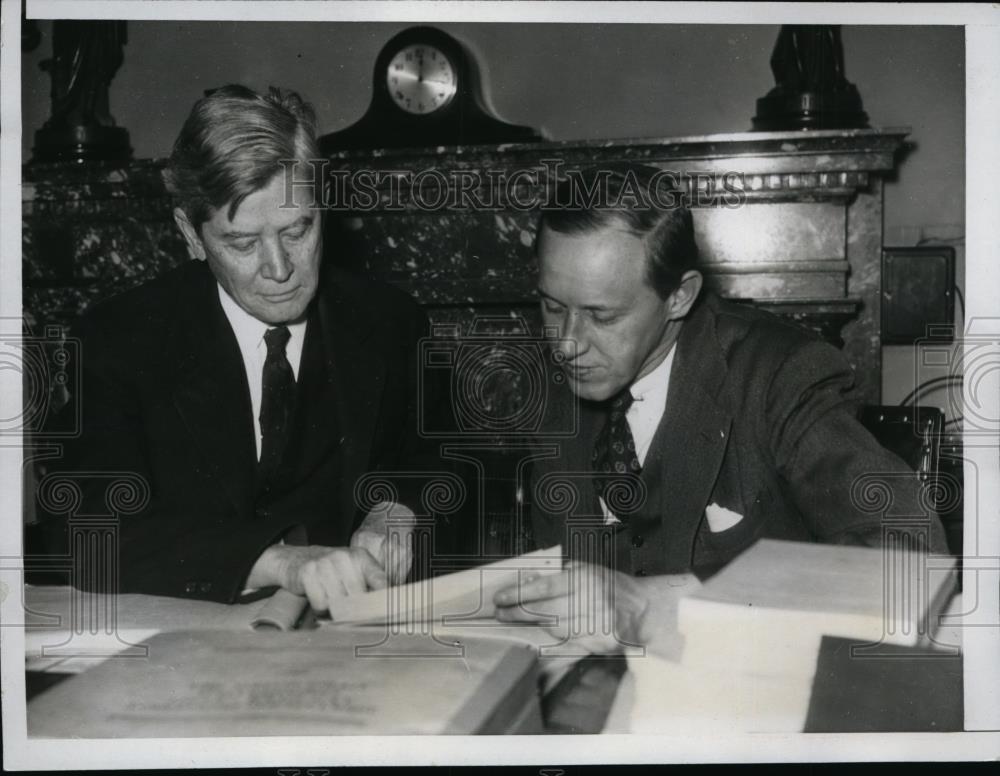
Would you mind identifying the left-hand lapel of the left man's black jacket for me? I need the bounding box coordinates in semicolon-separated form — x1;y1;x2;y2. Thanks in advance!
173;265;257;515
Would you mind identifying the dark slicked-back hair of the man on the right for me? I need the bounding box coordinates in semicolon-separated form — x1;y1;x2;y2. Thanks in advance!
539;163;698;299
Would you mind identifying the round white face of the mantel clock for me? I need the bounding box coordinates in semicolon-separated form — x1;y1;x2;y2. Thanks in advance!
386;43;458;115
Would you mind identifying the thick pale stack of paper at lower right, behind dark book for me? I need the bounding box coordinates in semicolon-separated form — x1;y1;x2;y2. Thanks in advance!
629;540;955;732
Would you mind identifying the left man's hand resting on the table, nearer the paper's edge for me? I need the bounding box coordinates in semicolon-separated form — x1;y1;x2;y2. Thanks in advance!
247;544;388;612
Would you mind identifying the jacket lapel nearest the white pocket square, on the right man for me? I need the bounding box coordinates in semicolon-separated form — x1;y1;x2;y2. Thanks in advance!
642;300;732;568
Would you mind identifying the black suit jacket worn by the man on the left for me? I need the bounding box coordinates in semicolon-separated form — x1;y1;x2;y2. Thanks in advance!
42;262;442;601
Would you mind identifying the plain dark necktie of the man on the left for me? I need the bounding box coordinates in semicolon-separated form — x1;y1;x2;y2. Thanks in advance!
259;326;295;479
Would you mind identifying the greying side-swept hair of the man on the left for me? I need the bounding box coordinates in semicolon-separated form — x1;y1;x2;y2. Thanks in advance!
163;84;322;228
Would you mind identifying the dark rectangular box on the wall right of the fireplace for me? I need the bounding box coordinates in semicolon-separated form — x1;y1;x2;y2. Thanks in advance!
882;246;955;345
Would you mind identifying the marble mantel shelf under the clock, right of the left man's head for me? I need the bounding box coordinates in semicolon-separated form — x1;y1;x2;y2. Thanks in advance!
320;127;909;212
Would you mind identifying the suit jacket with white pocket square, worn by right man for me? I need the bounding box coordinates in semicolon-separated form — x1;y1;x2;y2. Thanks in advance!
532;294;947;576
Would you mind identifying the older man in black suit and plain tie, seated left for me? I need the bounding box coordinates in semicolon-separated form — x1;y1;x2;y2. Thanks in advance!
45;86;438;611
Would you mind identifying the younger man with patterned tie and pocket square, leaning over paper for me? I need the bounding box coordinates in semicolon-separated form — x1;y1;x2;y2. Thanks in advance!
496;165;946;652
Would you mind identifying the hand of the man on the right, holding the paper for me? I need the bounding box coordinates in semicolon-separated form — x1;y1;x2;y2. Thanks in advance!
493;561;699;657
